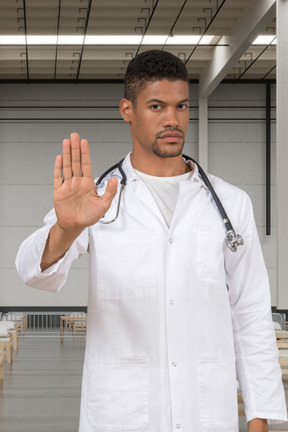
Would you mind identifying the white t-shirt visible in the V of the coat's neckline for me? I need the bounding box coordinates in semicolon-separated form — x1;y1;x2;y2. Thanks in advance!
134;168;192;227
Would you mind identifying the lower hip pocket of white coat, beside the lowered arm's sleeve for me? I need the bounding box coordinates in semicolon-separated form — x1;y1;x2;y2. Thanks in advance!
198;357;238;432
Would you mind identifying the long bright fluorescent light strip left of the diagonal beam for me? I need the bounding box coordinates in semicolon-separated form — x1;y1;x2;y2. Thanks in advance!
0;35;214;46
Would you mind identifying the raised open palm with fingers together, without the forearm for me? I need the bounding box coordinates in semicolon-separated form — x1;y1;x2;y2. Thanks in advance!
53;133;118;230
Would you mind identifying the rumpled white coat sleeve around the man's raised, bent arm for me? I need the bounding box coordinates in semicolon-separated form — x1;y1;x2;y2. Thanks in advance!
15;210;88;292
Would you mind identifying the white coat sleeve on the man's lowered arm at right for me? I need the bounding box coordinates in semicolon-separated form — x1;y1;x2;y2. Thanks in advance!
226;194;287;424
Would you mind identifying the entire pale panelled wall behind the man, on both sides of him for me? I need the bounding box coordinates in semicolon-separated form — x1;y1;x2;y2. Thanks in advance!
0;84;281;308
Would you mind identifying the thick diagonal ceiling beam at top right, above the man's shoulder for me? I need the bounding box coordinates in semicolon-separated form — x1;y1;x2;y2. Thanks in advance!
199;0;276;97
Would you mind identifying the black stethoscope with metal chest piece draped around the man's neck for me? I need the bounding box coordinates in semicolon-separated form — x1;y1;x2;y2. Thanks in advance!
95;155;244;252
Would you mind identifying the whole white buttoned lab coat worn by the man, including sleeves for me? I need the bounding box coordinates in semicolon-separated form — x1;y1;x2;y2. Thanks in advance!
16;156;287;432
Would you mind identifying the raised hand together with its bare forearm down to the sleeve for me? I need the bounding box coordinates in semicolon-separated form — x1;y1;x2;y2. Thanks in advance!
41;133;118;271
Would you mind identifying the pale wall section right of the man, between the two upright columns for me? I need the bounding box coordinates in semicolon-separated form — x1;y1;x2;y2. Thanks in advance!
209;84;281;309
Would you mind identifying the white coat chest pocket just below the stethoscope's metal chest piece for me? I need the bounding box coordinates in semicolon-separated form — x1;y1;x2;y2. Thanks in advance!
195;229;225;288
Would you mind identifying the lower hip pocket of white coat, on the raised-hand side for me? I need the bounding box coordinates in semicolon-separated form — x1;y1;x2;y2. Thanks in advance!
88;357;149;432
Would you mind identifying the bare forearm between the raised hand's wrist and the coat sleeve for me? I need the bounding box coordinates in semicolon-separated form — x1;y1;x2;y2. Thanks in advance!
41;222;83;271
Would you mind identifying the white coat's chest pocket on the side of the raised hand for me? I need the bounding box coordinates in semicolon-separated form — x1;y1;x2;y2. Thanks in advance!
95;230;157;300
